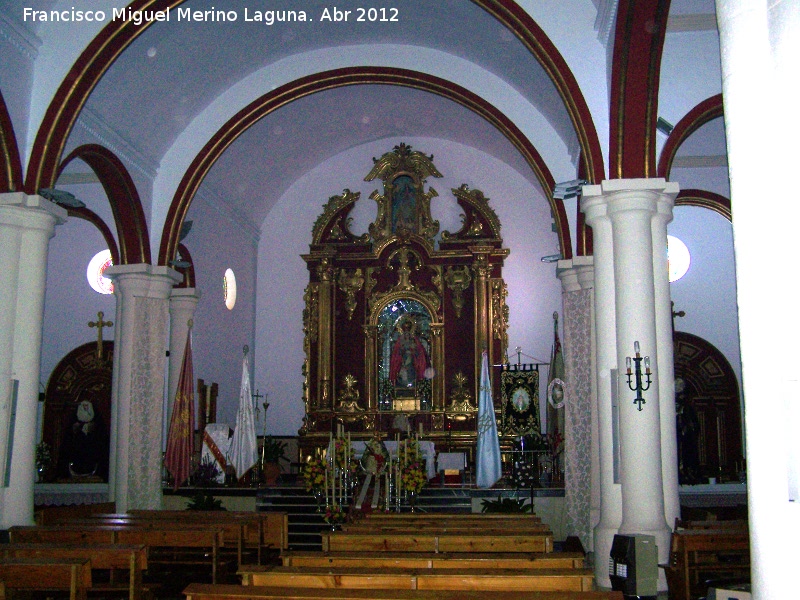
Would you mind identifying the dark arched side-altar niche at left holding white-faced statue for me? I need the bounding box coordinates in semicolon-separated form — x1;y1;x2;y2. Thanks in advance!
42;341;114;483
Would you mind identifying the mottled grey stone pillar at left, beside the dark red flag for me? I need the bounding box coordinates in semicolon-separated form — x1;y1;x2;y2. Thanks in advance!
106;264;182;512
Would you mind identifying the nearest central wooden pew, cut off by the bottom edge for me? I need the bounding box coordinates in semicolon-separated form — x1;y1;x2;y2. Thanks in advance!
183;583;623;600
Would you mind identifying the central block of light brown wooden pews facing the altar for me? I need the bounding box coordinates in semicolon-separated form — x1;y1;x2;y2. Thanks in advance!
184;513;622;600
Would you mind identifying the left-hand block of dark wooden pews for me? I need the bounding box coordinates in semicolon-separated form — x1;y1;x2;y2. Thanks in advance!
0;511;288;600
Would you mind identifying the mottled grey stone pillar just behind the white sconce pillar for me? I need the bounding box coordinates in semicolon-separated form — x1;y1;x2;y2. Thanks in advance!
557;256;599;552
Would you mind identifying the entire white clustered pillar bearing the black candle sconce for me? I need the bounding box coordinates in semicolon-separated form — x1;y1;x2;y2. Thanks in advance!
581;179;679;589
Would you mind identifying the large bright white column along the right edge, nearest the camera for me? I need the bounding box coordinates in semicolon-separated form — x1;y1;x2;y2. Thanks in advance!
717;0;800;600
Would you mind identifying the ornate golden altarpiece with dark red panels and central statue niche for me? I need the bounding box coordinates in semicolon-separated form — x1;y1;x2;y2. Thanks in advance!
300;144;508;464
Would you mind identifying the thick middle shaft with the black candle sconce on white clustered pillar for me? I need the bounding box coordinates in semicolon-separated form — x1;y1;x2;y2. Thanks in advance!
601;179;678;589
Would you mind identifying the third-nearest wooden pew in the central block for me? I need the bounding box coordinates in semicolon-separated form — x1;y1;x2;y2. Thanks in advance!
281;550;584;570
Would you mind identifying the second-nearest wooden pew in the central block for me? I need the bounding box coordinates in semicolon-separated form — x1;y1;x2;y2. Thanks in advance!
240;566;594;592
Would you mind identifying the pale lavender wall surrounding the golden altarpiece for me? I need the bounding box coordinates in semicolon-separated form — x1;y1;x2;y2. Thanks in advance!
253;138;561;435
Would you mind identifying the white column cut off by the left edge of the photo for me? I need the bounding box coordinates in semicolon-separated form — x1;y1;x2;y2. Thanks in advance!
0;193;67;529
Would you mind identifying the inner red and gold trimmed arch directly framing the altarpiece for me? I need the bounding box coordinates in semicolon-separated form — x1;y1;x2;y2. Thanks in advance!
158;67;572;265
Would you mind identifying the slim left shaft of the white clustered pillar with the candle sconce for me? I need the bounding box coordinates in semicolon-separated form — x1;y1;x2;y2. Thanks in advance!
581;190;622;588
